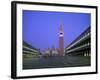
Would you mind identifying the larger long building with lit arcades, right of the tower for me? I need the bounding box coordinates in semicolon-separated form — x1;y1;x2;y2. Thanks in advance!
65;27;91;56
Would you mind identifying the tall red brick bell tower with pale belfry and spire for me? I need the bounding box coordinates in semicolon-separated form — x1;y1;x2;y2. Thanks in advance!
59;24;64;56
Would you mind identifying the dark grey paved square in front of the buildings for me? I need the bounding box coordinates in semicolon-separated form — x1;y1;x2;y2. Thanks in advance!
23;55;90;69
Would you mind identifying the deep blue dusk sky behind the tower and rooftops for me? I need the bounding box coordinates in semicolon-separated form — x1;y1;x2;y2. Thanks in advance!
23;10;91;50
